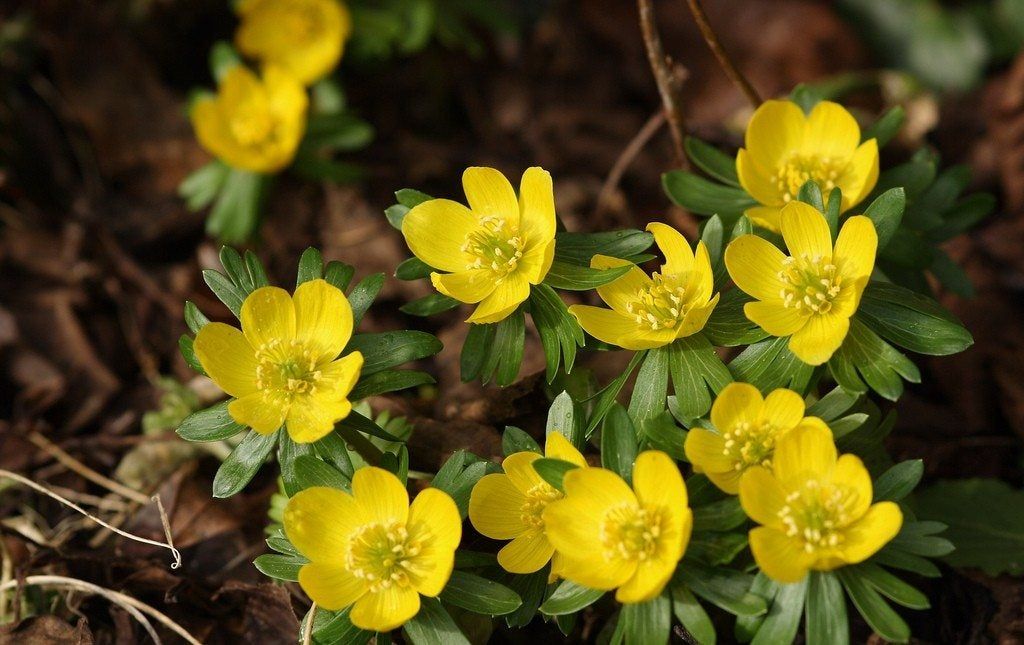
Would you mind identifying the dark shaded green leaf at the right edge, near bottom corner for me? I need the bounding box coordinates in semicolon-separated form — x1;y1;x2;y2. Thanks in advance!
909;479;1024;576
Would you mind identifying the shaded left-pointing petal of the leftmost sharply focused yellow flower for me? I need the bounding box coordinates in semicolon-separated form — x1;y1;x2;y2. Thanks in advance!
193;323;256;397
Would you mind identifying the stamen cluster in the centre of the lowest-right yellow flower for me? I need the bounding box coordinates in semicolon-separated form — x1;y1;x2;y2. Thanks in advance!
778;479;857;553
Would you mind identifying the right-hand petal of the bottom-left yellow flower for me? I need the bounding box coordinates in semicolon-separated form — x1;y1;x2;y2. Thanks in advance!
409;488;462;597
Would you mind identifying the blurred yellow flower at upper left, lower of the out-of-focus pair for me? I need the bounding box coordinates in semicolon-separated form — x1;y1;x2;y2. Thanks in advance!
191;66;308;173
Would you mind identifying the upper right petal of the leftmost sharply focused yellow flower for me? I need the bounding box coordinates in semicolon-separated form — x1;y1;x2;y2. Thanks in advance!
292;280;352;362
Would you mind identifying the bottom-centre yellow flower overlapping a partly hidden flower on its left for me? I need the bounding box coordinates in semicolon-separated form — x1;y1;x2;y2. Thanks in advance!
544;450;693;603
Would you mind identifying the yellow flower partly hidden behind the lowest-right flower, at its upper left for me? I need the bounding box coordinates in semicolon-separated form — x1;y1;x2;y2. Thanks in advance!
685;383;823;495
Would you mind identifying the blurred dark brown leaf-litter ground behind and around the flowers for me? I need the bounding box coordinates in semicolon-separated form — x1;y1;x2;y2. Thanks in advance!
0;0;1024;643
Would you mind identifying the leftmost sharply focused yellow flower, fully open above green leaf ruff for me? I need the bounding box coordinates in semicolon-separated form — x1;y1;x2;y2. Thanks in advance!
195;280;362;443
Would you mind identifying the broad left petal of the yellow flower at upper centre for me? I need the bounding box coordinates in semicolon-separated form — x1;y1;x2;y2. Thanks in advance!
401;200;479;271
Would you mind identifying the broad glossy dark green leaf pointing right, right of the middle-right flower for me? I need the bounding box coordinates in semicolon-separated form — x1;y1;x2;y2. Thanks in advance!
857;283;974;356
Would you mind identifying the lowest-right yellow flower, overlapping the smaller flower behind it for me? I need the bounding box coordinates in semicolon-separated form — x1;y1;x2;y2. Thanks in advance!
739;424;903;583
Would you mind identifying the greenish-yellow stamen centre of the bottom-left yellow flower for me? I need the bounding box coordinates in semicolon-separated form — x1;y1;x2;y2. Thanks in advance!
345;520;430;593
